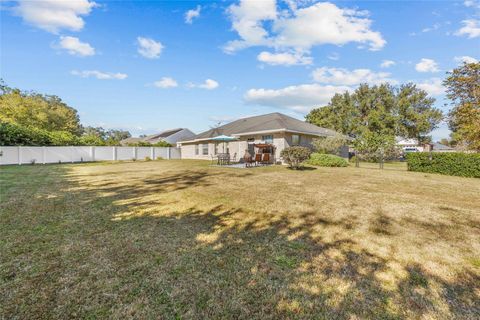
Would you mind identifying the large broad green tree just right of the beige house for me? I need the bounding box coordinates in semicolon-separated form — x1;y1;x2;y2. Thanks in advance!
306;84;443;141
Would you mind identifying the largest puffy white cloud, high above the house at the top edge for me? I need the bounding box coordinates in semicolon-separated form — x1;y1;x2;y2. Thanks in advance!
224;0;386;52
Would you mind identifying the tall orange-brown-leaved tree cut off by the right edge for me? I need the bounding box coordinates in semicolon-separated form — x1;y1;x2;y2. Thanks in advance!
443;62;480;152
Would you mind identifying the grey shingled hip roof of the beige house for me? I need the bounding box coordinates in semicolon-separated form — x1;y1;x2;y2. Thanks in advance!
183;112;336;140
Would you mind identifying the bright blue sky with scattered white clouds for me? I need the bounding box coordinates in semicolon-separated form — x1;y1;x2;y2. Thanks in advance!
0;0;480;139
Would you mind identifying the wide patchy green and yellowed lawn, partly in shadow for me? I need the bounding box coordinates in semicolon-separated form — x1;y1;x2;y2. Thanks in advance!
0;160;480;319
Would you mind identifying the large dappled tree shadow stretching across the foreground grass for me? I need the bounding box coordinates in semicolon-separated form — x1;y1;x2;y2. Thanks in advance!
0;165;480;319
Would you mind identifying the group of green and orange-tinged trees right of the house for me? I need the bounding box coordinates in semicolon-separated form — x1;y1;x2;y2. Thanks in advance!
306;63;480;154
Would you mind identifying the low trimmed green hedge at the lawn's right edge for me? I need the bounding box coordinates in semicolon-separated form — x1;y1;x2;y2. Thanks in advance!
406;152;480;178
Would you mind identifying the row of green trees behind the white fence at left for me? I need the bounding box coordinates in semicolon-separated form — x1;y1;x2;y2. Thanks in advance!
0;81;136;146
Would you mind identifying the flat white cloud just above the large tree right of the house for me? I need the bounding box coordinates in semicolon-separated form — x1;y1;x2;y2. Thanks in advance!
312;67;397;86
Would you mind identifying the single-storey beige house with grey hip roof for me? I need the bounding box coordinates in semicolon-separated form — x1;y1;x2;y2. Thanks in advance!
177;112;348;161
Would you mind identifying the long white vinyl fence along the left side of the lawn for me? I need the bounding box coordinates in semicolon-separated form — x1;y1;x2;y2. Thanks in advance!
0;146;180;165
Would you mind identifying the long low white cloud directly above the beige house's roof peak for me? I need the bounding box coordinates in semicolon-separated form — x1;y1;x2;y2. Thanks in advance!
244;84;351;113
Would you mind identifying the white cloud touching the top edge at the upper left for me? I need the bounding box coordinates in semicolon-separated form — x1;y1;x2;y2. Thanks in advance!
14;0;97;33
